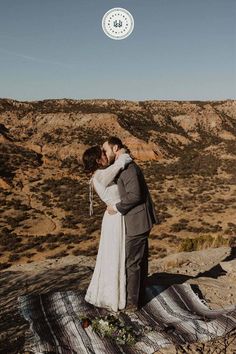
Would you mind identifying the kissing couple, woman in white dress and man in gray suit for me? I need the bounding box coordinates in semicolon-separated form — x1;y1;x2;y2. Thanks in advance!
82;136;157;312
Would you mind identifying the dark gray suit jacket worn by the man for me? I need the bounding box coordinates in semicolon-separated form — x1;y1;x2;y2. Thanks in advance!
116;161;158;236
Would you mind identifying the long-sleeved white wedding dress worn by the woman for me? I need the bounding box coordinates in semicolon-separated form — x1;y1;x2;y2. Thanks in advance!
85;153;132;312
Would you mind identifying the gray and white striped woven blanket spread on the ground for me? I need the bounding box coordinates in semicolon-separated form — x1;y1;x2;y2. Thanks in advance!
19;284;236;354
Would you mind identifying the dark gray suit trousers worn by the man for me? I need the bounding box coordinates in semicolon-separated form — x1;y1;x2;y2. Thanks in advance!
125;231;150;307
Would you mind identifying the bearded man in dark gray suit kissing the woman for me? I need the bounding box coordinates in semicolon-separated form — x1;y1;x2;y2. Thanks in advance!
103;136;157;312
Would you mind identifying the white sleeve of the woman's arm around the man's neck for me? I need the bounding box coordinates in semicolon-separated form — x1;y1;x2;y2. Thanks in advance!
94;153;132;187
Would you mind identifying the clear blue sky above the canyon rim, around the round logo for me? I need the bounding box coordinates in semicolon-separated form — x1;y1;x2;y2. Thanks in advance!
0;0;236;100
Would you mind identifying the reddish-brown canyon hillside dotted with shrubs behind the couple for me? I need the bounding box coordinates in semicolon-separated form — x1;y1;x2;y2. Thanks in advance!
0;99;236;269
